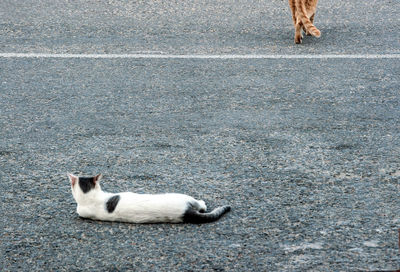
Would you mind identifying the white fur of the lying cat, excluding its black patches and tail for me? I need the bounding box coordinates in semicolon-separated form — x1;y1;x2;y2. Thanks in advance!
68;174;207;223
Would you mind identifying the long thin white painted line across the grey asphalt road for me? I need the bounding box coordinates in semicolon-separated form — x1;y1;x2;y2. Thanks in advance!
0;53;400;59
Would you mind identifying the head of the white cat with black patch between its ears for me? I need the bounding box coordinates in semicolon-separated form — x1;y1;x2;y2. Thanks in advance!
68;174;102;203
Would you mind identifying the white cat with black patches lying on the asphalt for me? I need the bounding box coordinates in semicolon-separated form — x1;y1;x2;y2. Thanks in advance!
68;174;231;224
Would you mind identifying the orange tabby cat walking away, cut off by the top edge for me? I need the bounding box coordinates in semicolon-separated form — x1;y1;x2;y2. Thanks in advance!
289;0;321;44
